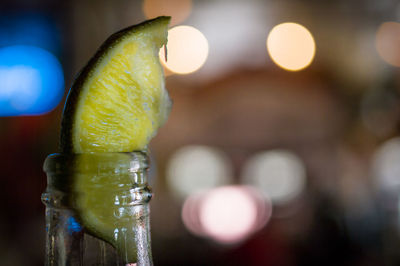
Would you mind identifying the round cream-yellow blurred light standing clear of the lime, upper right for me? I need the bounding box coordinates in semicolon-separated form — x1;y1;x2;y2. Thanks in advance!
267;22;315;71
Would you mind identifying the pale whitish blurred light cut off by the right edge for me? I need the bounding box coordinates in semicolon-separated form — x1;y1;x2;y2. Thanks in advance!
373;138;400;191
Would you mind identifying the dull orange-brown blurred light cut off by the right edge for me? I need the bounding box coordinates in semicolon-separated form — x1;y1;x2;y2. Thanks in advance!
375;22;400;67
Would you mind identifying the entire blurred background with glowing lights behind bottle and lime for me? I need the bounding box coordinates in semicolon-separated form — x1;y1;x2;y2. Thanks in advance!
0;0;400;266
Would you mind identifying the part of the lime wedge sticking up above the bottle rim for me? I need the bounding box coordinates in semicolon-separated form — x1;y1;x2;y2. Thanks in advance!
60;17;171;153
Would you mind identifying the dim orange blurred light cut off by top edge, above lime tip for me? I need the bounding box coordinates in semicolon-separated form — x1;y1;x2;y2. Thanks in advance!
143;0;192;25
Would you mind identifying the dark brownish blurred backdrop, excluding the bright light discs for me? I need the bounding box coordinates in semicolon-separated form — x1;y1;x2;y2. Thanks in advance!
0;0;400;266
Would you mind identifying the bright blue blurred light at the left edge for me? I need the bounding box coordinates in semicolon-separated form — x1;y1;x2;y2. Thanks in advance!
0;45;64;116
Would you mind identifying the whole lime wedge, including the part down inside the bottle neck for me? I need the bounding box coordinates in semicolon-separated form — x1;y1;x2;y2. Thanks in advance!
56;17;171;261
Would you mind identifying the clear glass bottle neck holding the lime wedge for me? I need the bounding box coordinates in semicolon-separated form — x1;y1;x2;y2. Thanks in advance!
42;152;152;266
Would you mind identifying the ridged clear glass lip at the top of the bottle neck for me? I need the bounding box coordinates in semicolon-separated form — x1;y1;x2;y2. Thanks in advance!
42;152;152;208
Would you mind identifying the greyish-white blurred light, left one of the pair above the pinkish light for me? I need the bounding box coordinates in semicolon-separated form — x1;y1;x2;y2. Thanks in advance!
167;146;232;198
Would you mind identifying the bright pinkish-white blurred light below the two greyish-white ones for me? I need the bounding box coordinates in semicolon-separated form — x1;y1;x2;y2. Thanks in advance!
182;186;272;244
